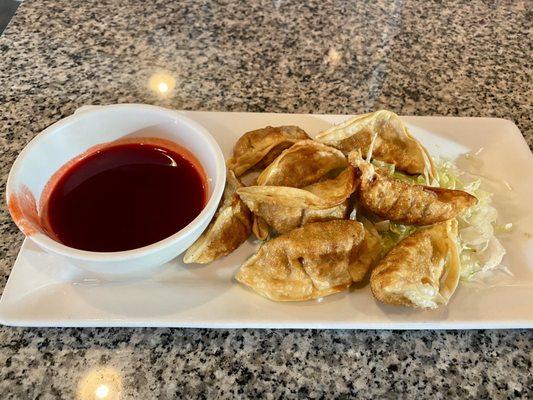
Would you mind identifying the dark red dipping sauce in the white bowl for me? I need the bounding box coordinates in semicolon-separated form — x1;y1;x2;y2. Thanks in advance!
43;140;207;252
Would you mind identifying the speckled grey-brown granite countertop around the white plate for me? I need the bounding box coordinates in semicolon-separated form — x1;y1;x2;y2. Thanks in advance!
0;0;533;399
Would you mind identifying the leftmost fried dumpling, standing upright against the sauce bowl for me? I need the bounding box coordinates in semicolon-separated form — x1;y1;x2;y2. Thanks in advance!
183;170;252;264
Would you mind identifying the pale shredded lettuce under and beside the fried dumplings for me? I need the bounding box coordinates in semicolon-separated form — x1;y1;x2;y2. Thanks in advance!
372;160;504;281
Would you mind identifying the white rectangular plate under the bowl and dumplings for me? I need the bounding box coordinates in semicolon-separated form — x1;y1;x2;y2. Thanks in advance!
0;111;533;329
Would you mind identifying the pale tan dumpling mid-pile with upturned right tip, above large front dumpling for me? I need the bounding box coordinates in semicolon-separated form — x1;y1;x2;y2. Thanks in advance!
237;166;356;233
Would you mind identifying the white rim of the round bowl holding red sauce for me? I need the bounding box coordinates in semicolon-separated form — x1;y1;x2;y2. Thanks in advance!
6;103;226;262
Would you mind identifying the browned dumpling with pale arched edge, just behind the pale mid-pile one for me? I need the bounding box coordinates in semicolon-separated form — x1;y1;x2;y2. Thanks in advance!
257;140;348;188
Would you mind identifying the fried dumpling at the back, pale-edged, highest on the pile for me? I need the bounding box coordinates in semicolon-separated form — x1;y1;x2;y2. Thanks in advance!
316;110;435;177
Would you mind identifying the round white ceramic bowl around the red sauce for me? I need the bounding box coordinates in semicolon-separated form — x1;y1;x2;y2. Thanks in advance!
6;104;226;275
